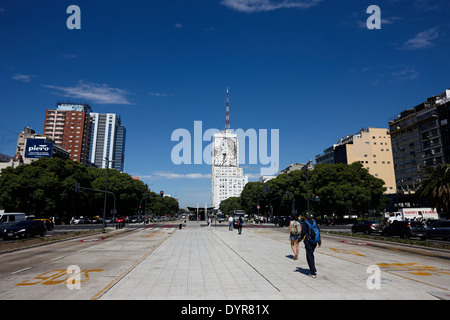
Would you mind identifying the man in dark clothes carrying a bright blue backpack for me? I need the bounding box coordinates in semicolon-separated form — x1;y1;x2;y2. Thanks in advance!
298;212;322;278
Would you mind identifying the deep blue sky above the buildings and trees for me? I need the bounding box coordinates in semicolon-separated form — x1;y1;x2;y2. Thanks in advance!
0;0;450;207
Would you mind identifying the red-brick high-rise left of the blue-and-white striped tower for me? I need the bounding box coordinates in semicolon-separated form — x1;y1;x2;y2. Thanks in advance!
44;103;92;165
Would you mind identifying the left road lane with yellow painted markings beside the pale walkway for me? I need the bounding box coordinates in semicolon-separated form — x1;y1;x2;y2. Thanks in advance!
0;228;176;300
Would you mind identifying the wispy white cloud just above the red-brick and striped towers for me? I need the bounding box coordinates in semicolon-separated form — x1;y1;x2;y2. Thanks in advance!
44;80;132;104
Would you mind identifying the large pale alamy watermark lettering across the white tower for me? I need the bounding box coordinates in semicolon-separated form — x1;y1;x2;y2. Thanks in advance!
171;121;280;176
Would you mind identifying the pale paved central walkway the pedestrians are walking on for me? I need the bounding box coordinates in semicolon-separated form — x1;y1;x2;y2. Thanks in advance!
99;222;444;300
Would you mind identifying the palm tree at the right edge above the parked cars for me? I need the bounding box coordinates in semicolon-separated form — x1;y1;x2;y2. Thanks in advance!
417;164;450;216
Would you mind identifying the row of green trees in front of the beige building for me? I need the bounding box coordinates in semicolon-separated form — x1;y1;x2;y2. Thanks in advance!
240;163;389;216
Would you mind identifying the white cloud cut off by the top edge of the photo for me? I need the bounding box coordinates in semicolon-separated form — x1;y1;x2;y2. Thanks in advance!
220;0;322;13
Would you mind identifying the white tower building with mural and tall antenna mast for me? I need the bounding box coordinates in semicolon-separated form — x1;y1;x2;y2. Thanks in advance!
211;88;248;209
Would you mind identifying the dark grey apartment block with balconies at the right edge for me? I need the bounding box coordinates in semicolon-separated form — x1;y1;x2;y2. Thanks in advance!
389;90;450;194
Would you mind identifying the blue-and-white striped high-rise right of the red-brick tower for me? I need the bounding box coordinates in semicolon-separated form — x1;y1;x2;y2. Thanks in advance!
89;113;126;171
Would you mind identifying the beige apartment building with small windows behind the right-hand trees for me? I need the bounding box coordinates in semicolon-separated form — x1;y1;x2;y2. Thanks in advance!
316;128;396;194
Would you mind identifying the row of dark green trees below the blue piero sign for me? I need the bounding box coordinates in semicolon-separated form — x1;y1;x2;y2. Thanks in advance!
0;158;171;218
